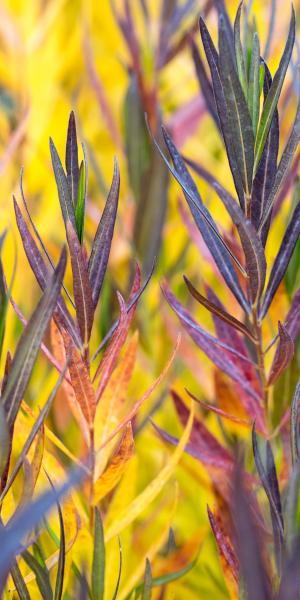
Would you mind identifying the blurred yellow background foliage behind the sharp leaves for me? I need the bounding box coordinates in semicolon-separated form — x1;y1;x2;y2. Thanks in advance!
0;0;300;600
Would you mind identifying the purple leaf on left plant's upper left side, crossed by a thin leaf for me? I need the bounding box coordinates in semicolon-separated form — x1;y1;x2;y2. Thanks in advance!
14;198;81;348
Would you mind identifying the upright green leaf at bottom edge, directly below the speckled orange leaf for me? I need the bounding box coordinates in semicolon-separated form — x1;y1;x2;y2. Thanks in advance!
92;508;105;600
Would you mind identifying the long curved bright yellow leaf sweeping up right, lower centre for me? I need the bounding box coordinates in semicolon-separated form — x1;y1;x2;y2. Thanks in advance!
105;403;194;542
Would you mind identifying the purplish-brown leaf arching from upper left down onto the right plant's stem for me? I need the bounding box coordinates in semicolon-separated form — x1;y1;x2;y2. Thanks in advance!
188;160;266;304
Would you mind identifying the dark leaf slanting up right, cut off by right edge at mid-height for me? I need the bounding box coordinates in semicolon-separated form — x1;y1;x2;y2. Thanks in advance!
259;202;300;319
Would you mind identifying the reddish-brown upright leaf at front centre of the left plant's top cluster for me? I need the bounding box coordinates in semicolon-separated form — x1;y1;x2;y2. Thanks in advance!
66;221;94;347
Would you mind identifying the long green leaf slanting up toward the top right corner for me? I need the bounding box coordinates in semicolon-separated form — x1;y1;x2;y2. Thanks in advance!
254;7;295;174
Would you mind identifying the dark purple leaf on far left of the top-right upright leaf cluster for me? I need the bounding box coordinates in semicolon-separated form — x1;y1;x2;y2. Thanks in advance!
199;17;245;209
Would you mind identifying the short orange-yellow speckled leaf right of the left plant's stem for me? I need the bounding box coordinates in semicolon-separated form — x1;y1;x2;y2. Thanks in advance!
93;423;134;506
